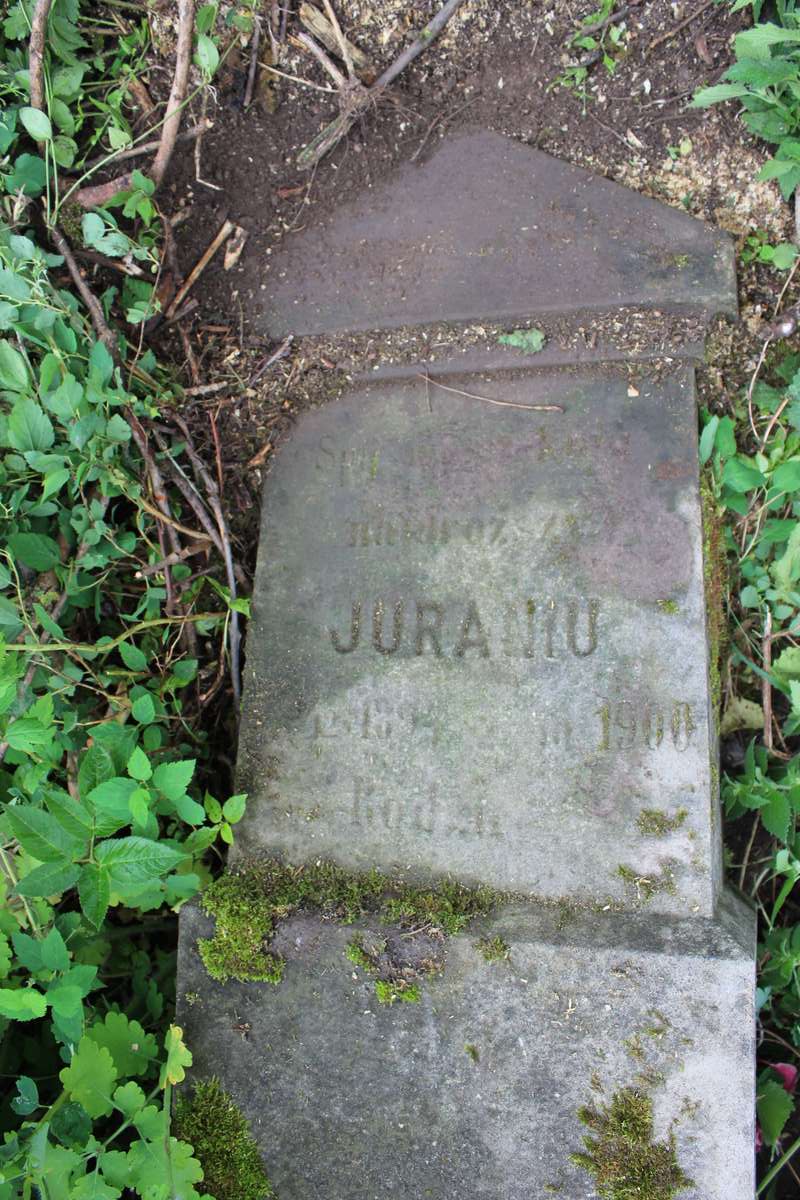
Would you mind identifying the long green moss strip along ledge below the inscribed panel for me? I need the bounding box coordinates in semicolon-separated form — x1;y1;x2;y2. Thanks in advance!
198;859;500;983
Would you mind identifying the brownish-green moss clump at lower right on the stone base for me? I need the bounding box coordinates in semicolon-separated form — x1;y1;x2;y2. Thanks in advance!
571;1087;692;1200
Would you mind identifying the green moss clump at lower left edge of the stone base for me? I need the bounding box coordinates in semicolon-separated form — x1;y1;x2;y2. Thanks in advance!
175;1079;275;1200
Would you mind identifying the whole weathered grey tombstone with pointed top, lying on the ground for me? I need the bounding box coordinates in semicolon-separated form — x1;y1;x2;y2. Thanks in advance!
179;133;754;1200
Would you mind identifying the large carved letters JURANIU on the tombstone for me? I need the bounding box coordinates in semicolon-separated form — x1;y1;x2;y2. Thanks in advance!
327;596;600;660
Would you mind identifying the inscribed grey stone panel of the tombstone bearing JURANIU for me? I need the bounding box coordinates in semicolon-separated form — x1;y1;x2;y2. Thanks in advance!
237;367;718;913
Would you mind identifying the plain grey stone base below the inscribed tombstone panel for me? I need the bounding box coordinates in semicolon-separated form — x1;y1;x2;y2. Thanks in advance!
178;895;754;1200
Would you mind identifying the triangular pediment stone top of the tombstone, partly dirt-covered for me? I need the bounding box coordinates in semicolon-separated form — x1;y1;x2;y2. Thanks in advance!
253;132;736;337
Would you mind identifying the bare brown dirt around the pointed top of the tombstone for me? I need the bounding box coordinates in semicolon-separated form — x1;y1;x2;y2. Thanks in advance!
153;0;792;560
